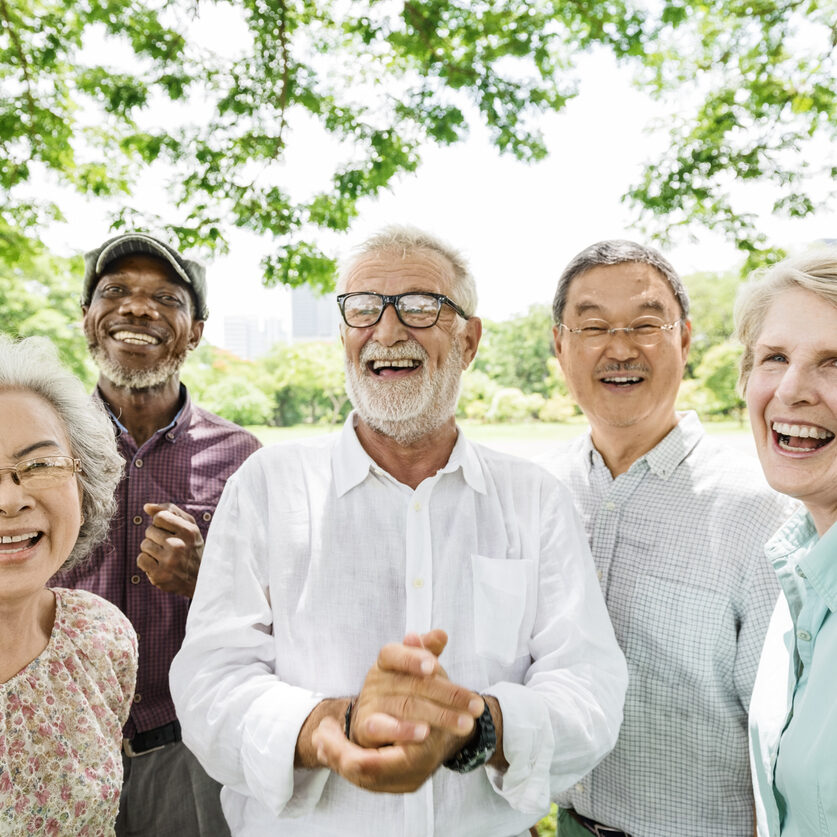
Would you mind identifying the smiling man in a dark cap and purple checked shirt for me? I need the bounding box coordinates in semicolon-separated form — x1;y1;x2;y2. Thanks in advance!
57;232;259;837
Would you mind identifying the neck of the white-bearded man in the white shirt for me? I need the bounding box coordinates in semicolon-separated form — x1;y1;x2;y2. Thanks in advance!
355;416;456;489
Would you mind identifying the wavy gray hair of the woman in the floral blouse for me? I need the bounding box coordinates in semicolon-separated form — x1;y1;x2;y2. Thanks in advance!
0;334;124;570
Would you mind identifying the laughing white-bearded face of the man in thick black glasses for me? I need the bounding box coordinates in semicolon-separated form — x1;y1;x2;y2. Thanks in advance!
342;250;480;444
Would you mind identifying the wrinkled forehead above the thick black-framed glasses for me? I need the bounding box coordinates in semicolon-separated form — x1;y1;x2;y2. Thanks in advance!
340;249;454;296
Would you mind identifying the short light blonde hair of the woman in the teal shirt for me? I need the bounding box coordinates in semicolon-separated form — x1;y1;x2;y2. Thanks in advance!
735;247;837;394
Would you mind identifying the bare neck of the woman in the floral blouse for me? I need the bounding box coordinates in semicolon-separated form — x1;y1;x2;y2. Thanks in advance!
0;588;55;683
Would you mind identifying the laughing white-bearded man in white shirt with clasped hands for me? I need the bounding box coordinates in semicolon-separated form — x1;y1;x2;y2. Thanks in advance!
171;228;627;837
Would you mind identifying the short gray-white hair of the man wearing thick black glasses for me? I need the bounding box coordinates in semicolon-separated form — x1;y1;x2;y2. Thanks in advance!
337;224;477;317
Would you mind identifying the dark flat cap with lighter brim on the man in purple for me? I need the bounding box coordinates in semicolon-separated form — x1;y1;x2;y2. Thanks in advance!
81;232;209;320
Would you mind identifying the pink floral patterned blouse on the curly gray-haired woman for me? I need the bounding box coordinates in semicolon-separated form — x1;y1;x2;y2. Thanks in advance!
0;588;137;837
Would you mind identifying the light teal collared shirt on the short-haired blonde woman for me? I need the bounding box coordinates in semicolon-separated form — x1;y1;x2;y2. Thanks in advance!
750;510;837;837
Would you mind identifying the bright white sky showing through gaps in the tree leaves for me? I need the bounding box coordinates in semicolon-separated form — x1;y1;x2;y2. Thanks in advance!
48;7;837;345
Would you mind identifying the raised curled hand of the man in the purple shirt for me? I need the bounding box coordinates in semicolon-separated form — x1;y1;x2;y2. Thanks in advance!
137;503;203;598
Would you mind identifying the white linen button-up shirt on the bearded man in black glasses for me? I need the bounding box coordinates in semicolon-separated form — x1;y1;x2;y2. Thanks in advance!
171;415;627;837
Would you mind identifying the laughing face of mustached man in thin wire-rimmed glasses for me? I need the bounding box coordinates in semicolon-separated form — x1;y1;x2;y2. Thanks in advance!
554;262;690;464
